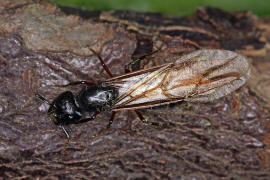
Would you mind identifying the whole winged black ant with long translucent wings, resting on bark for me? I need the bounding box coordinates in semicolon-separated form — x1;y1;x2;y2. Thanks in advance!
36;50;250;138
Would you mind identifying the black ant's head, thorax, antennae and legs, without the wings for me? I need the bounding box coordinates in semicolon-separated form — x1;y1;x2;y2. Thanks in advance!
35;49;147;139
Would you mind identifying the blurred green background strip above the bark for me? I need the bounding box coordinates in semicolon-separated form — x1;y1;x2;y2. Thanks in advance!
48;0;270;16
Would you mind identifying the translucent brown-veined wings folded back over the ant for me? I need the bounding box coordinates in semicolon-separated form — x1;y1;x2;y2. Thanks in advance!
105;50;250;111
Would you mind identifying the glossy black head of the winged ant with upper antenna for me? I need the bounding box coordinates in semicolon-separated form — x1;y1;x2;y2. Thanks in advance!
36;91;82;125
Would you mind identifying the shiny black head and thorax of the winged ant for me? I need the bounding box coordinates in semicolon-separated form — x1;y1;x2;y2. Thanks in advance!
48;84;118;125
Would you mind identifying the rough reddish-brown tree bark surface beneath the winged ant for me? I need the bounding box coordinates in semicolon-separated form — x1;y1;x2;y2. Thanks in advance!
0;0;270;179
